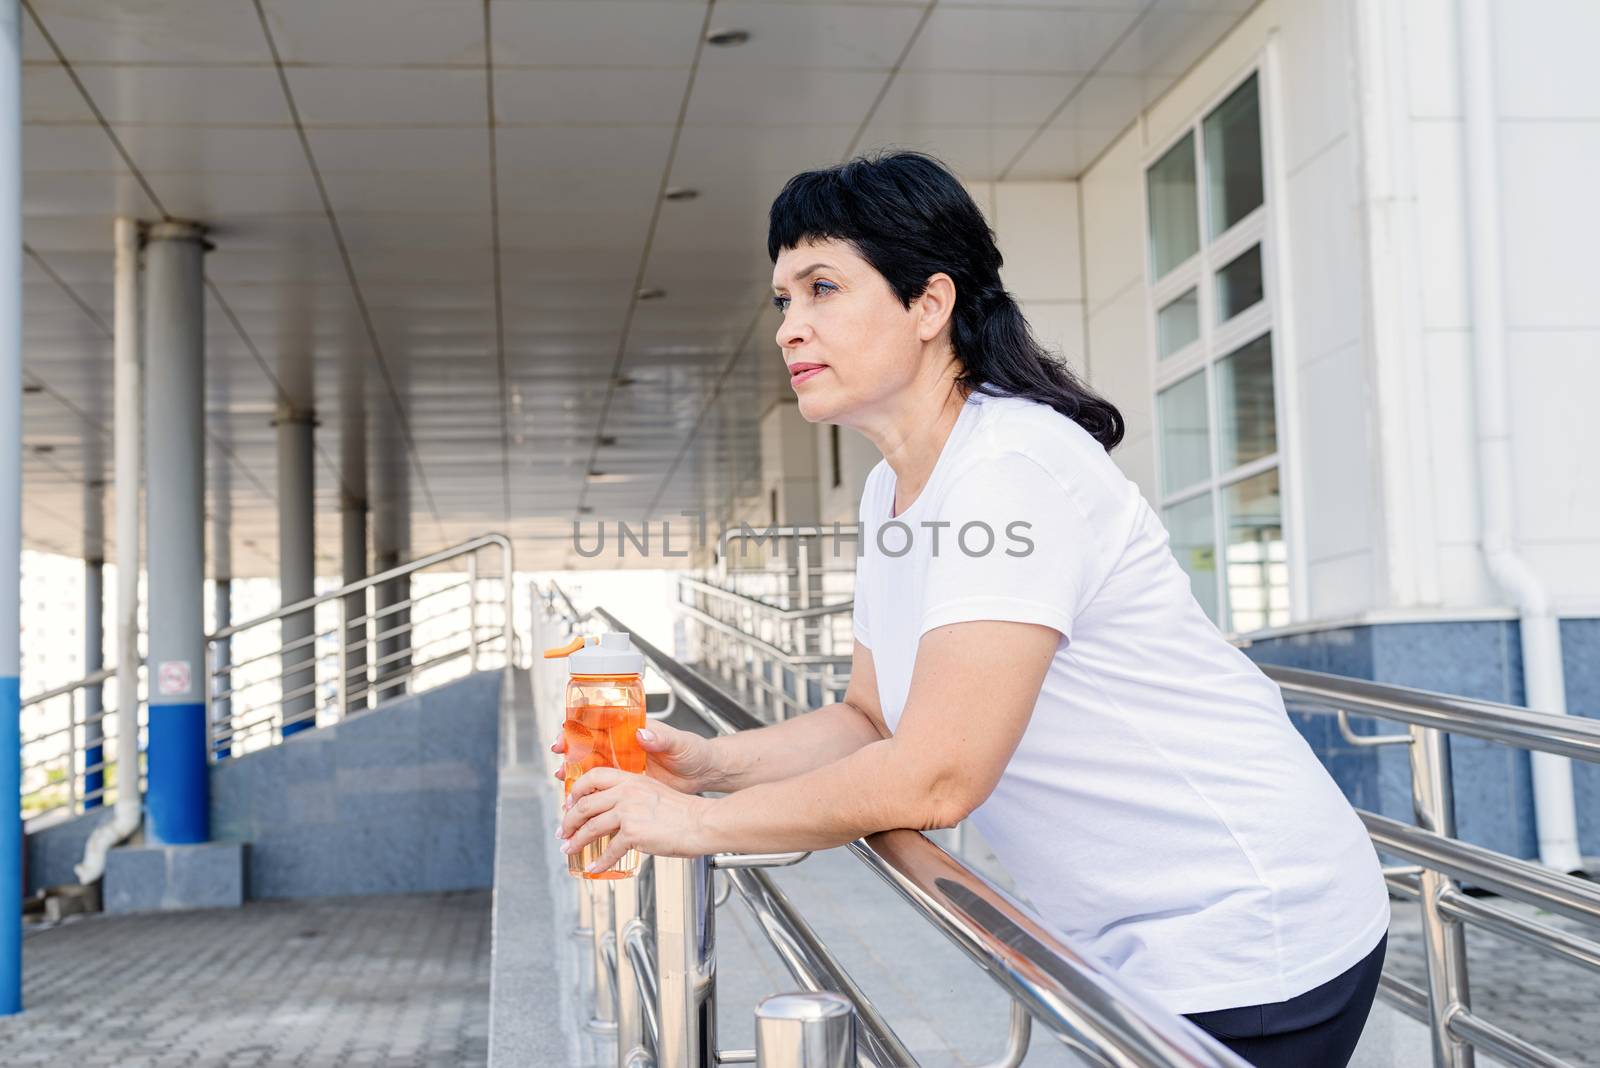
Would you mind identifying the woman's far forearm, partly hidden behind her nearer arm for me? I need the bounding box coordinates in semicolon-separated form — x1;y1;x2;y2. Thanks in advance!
706;703;883;793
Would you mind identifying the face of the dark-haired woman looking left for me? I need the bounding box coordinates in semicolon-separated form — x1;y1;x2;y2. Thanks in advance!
773;241;926;425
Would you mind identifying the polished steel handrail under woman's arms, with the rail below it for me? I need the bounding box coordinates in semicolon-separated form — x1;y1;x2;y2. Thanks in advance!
540;588;1246;1068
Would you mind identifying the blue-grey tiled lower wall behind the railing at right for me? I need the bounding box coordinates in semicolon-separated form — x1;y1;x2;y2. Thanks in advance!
1245;619;1600;857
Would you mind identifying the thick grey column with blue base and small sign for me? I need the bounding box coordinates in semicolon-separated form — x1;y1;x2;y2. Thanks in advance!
142;222;211;846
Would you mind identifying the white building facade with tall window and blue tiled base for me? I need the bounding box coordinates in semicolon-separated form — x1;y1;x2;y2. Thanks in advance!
752;0;1600;867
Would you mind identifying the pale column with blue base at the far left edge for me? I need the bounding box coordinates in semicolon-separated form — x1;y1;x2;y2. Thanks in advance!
0;0;22;1015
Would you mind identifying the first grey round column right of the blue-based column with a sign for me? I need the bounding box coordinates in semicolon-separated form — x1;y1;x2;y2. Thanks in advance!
274;404;317;737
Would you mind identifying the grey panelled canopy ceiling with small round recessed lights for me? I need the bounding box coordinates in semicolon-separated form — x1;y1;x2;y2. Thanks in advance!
22;0;1248;576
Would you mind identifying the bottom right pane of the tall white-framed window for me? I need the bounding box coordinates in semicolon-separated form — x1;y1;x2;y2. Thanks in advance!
1222;468;1290;633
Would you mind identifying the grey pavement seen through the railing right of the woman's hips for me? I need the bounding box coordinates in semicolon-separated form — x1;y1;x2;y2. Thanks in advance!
1384;897;1600;1068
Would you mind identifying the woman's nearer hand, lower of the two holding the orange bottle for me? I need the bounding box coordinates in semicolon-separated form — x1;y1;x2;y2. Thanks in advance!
555;767;715;871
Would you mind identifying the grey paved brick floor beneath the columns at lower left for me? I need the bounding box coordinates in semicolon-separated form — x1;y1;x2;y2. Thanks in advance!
0;891;490;1068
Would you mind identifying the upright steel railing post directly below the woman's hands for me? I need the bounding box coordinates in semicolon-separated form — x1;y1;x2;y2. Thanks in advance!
654;857;717;1068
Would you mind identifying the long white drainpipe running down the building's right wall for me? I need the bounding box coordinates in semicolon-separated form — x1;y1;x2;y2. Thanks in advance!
1459;0;1582;871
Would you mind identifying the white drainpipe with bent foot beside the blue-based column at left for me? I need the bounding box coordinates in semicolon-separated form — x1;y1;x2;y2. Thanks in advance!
72;219;142;886
